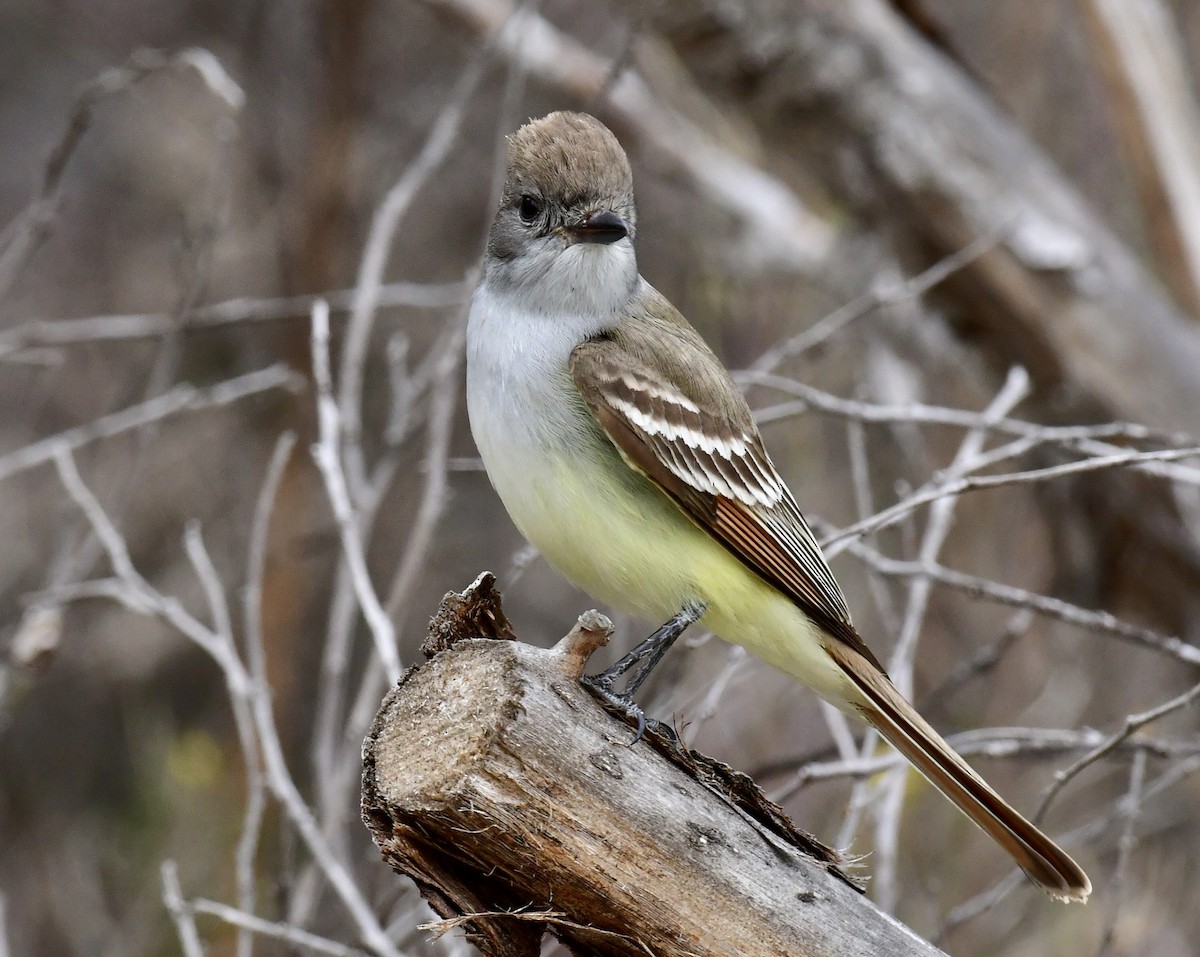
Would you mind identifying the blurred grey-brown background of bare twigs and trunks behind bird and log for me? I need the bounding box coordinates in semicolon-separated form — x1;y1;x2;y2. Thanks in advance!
0;0;1200;956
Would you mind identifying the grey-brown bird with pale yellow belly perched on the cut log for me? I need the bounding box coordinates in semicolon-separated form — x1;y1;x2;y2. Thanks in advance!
467;113;1091;901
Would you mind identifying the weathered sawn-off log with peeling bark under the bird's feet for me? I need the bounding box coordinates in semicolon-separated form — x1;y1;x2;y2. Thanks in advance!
362;576;940;957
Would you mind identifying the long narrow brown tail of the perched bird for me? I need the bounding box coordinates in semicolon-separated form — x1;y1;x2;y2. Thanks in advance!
826;639;1092;902
